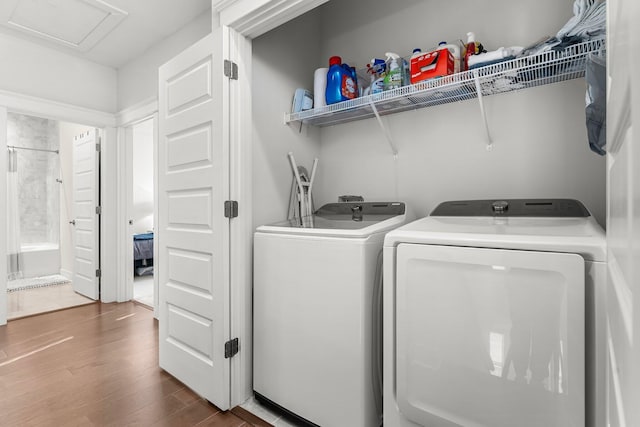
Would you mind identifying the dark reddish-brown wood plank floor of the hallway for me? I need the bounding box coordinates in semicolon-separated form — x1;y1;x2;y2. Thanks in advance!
0;303;269;427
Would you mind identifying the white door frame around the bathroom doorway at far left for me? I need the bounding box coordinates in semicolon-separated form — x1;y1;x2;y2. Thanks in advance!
0;91;117;325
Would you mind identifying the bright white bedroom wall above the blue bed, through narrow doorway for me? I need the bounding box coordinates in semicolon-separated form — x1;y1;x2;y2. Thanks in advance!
131;120;153;233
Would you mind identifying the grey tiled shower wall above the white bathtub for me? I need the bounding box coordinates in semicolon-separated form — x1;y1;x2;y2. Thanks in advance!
7;113;60;245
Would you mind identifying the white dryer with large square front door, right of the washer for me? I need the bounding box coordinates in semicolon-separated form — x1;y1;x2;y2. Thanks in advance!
383;199;606;427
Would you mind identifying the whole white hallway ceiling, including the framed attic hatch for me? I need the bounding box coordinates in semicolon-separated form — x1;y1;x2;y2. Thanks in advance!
0;0;211;68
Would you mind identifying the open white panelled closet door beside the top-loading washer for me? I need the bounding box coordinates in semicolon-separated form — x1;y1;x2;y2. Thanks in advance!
157;28;230;409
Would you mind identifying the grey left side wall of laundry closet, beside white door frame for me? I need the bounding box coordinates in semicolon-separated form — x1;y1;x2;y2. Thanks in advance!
252;12;324;226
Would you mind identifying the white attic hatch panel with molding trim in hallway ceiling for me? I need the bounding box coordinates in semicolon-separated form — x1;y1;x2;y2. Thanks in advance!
0;0;127;52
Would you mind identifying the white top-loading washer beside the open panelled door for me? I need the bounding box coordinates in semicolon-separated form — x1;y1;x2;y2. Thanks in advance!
253;202;405;427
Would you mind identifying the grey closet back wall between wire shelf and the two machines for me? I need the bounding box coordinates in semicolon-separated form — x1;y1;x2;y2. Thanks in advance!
318;81;605;225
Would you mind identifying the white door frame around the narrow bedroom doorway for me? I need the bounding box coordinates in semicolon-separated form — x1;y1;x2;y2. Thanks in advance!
116;98;159;319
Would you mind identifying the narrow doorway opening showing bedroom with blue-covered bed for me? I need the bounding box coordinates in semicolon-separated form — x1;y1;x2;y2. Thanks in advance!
125;117;157;309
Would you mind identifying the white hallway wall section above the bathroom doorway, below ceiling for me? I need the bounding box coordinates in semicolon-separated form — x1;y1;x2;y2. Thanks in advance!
0;34;117;113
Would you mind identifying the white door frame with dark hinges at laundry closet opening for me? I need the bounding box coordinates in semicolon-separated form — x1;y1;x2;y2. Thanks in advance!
211;0;329;407
